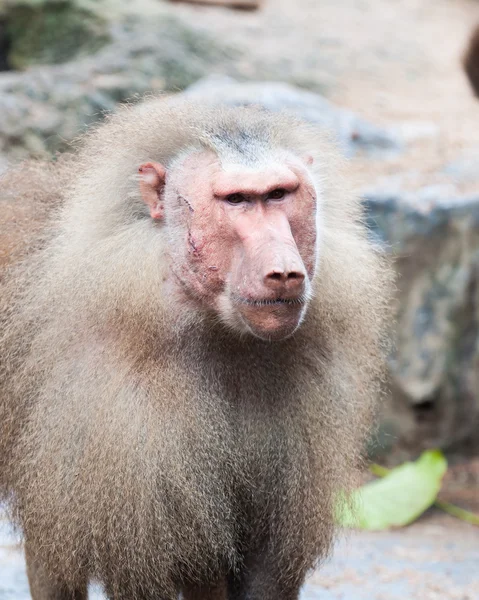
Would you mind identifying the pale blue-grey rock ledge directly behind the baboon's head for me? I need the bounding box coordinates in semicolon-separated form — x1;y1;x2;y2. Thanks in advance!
185;76;402;157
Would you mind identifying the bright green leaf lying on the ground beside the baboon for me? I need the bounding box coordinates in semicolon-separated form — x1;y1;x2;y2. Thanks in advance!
338;450;447;531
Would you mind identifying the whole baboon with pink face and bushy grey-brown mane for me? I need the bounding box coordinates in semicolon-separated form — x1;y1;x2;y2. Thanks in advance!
0;99;390;600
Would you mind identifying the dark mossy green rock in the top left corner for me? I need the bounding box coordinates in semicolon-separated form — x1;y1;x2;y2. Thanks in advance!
3;0;110;69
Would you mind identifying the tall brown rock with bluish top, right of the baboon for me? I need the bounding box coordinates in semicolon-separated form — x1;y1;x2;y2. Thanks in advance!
364;188;479;450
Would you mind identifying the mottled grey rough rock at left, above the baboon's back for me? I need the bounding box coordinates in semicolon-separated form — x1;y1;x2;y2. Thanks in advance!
0;14;236;161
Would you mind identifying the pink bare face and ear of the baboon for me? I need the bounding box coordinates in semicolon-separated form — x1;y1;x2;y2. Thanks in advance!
140;151;317;340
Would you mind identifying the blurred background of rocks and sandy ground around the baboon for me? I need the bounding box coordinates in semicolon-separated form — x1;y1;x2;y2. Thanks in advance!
0;0;479;600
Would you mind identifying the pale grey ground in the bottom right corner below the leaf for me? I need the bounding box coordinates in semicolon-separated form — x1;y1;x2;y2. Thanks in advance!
308;511;479;600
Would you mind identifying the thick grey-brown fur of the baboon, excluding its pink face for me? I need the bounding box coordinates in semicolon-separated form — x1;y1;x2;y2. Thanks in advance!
0;100;389;600
